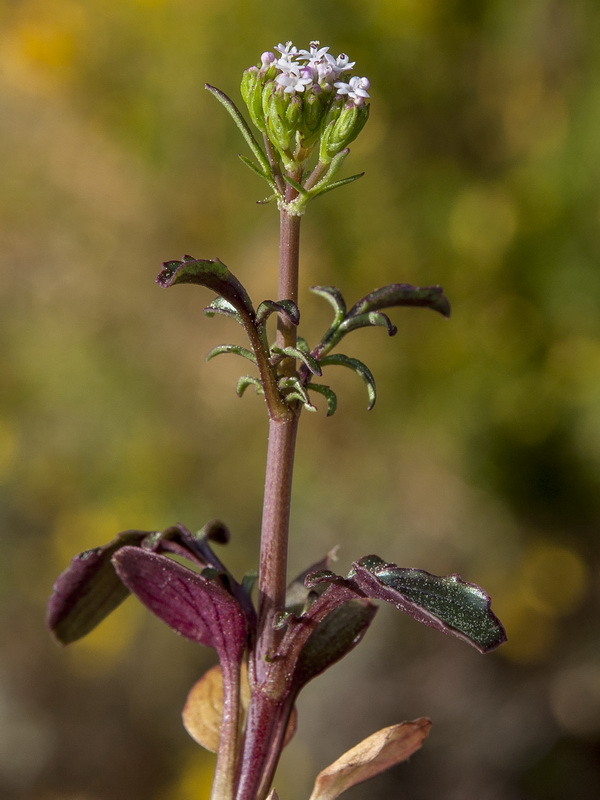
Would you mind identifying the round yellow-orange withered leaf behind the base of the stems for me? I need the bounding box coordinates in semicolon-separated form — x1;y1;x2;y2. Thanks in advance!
182;664;298;753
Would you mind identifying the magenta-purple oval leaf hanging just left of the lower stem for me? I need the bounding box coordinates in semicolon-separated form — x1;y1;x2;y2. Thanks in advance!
113;547;248;663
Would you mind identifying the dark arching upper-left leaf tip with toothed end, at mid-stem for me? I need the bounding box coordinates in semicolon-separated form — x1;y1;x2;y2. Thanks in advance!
156;256;254;319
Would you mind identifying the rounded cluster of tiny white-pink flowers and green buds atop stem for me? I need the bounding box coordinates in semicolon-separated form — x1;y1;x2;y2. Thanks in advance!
241;42;370;172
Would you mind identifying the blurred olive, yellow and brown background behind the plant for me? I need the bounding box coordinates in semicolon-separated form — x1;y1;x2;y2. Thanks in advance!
0;0;600;800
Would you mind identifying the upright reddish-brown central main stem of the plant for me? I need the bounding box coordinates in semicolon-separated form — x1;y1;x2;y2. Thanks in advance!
236;181;301;800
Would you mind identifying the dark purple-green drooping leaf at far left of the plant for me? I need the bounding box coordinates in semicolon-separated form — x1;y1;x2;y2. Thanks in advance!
46;530;152;644
